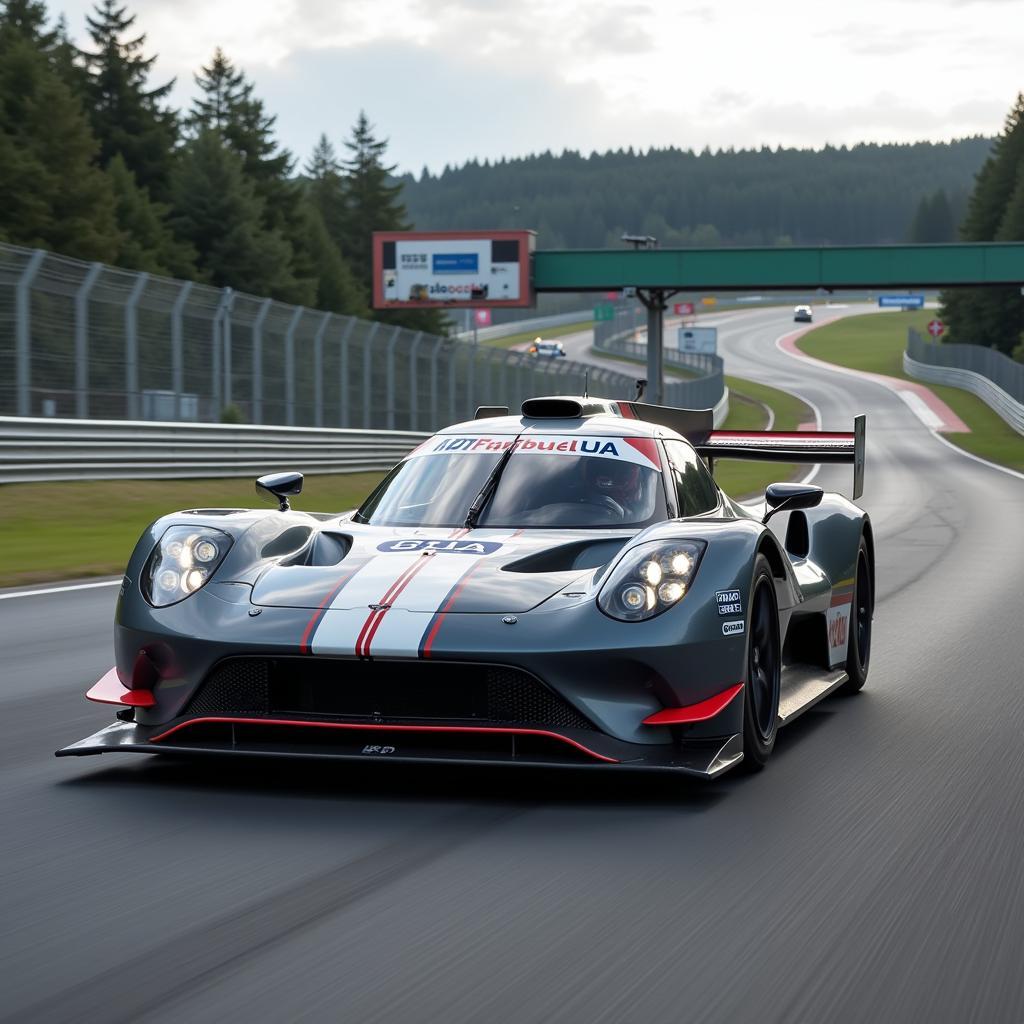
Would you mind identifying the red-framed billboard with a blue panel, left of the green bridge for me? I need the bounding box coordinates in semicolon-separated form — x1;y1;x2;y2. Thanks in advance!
374;231;537;309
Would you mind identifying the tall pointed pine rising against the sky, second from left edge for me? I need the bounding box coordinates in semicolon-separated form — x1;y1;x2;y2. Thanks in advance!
81;0;177;200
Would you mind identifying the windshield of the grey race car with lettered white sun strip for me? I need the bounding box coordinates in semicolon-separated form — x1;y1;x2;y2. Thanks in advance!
356;435;666;528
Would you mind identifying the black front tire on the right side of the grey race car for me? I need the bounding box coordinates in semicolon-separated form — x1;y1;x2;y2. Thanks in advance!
742;555;782;771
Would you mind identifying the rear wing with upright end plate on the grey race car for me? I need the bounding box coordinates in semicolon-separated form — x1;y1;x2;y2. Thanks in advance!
689;415;867;501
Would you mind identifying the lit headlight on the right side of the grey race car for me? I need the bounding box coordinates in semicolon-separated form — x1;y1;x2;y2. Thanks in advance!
597;541;707;623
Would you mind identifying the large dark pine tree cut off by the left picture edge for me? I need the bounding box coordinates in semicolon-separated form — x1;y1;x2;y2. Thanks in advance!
0;28;120;260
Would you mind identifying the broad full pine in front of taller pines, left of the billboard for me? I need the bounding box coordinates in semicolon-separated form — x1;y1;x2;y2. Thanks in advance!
172;131;296;298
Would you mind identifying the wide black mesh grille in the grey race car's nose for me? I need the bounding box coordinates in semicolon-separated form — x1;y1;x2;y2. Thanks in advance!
185;657;594;729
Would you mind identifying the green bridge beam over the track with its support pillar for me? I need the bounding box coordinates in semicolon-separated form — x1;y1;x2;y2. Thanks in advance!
532;240;1024;403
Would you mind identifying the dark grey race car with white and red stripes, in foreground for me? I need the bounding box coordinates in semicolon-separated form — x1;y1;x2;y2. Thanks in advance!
57;396;874;778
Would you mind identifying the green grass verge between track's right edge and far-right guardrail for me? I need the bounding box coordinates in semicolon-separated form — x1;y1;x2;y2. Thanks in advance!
798;309;1024;471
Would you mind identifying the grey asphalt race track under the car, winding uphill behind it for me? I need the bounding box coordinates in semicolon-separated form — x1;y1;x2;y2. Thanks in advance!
0;310;1024;1024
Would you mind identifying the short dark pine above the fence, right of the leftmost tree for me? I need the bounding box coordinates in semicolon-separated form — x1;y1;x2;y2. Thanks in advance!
106;154;197;278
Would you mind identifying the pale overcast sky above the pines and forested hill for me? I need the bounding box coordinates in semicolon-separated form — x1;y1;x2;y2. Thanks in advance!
50;0;1024;173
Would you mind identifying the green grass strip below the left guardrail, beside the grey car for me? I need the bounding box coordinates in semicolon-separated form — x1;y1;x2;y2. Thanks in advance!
0;473;383;587
